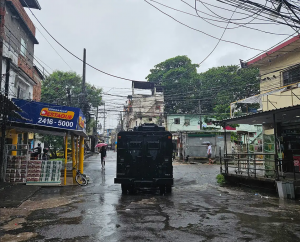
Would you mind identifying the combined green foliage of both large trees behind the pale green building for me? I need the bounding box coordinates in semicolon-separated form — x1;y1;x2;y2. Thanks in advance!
146;56;259;117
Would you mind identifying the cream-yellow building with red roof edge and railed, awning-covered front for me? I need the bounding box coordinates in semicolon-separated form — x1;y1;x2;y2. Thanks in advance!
221;35;300;196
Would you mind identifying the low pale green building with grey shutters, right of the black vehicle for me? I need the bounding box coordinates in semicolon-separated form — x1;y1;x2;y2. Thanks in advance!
167;114;262;160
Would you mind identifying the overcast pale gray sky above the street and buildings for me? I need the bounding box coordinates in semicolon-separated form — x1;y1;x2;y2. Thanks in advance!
27;0;293;128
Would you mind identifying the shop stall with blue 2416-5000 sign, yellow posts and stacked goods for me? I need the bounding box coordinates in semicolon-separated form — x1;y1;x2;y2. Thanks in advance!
6;99;86;185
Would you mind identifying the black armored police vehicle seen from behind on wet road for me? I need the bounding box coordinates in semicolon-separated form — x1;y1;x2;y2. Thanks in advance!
115;124;173;194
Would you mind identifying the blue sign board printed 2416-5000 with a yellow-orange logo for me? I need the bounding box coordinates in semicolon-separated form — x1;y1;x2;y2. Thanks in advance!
11;99;86;133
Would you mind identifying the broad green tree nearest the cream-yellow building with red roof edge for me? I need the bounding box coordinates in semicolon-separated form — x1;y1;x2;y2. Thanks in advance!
199;65;259;119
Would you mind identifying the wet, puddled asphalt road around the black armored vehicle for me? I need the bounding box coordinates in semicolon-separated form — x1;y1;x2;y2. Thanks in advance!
0;151;300;242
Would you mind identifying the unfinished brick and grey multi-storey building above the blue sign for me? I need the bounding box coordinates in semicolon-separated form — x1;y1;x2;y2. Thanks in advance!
0;0;43;101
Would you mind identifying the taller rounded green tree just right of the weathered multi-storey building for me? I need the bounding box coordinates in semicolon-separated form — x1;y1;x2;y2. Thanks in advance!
146;56;199;113
